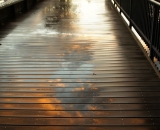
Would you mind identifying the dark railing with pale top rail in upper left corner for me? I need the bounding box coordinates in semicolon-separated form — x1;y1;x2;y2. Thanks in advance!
0;0;40;25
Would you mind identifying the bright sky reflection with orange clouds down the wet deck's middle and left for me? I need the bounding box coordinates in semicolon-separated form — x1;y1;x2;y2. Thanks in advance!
0;0;151;127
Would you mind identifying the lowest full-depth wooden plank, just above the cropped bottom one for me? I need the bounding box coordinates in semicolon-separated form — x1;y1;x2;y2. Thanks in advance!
0;117;158;126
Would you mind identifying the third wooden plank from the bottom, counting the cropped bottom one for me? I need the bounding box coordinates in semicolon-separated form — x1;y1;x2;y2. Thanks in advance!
0;110;160;118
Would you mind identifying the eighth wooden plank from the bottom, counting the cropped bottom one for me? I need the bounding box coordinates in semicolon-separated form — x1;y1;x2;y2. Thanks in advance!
0;81;160;89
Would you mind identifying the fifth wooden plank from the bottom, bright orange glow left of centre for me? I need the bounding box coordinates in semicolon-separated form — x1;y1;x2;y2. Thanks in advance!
0;97;160;104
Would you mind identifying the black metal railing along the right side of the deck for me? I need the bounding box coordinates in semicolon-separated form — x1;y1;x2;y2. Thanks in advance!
111;0;160;75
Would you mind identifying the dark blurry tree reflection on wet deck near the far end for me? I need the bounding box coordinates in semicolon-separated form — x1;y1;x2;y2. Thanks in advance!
45;0;78;34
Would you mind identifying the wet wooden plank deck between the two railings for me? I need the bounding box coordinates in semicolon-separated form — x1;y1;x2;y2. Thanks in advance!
0;0;160;130
